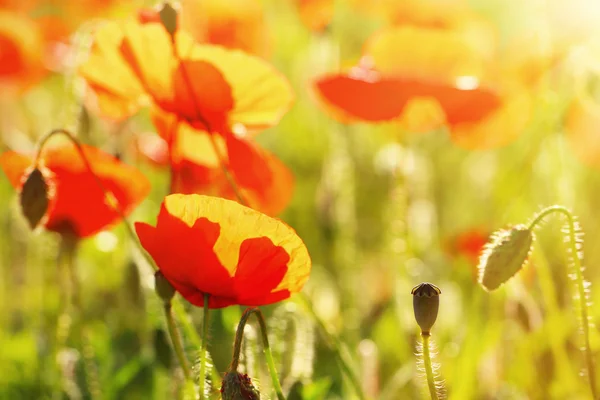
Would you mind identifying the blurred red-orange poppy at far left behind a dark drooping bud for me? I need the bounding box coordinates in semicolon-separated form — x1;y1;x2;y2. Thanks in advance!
0;145;150;238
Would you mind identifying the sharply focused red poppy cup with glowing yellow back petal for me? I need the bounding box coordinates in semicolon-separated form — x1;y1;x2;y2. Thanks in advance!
135;194;311;308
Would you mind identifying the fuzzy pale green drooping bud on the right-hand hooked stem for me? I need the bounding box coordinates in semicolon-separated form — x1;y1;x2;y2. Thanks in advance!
478;225;534;290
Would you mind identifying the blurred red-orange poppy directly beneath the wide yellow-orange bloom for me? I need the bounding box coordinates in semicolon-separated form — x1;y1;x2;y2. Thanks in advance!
149;113;294;215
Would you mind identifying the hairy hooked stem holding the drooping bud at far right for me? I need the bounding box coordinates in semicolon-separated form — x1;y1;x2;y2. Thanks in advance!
529;206;598;399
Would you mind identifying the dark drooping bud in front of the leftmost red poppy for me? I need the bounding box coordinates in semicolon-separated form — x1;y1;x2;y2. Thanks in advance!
19;168;50;229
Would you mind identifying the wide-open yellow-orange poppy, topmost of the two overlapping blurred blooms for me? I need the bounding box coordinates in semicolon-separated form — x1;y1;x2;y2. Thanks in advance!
80;22;293;132
